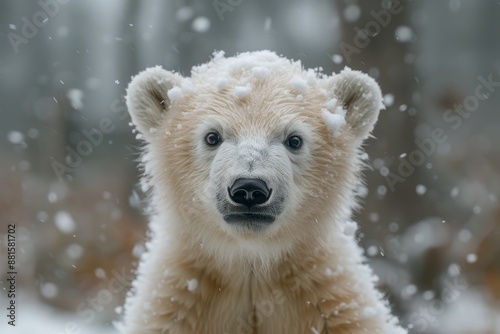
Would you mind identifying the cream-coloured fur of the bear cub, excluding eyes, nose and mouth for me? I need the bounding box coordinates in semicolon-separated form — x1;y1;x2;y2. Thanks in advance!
122;51;406;334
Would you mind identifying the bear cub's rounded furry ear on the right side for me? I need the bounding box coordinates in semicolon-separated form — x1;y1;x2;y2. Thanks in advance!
332;68;385;140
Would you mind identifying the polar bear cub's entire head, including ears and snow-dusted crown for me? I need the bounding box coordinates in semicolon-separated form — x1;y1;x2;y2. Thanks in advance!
127;51;382;268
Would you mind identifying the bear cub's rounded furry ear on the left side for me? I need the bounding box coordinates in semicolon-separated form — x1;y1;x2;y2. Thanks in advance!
126;66;182;138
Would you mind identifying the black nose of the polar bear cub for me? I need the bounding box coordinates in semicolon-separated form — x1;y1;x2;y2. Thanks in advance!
228;179;271;206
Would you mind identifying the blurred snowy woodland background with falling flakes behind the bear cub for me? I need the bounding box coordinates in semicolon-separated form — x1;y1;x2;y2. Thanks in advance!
0;0;500;334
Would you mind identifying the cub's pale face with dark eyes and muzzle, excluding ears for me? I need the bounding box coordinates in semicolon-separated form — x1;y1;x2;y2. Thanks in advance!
187;80;321;234
